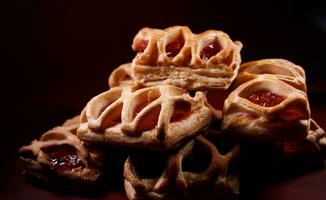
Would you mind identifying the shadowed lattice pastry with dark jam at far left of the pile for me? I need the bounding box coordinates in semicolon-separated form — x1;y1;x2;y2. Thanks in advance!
19;116;103;188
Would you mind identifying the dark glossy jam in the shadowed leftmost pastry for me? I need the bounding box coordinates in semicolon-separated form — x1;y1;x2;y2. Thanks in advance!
42;145;84;171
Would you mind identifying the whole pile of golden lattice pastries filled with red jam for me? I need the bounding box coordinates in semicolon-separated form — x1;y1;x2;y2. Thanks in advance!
20;26;326;199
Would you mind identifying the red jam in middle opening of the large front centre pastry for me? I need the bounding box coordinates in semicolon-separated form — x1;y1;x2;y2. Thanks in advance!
136;105;161;133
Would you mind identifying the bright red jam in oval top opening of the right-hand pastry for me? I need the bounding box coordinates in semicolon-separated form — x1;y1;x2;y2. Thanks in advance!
248;90;285;107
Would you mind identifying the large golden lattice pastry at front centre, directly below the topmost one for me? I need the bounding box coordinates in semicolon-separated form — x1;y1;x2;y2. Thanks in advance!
77;85;211;150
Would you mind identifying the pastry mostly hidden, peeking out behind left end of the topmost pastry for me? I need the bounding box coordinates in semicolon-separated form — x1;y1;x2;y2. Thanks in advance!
109;63;135;88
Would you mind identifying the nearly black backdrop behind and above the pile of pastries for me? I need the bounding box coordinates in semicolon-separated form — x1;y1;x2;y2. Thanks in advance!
0;0;326;199
